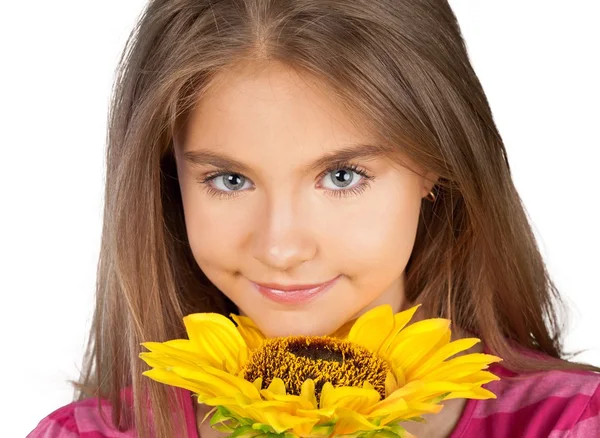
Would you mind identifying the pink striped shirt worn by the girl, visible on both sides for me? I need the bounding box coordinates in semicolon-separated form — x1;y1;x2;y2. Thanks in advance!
27;364;600;438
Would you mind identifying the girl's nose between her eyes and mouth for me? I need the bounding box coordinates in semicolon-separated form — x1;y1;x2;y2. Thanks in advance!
252;194;317;271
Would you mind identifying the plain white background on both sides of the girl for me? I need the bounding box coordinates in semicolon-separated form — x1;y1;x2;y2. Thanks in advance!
0;0;600;437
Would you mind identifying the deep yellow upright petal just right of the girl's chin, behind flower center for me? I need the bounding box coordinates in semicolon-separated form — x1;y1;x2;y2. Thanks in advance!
348;304;394;352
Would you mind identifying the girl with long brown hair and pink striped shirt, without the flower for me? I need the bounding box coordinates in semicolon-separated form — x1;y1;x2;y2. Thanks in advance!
29;0;600;438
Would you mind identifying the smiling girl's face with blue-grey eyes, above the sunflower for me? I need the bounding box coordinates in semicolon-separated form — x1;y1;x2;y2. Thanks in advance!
175;64;434;336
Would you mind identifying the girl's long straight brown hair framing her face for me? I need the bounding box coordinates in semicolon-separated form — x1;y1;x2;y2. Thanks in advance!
73;0;598;437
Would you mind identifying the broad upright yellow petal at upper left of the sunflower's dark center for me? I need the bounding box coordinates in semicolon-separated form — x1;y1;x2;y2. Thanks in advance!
183;313;247;374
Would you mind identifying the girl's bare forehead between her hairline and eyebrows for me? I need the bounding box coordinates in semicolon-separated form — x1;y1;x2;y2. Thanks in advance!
179;63;375;150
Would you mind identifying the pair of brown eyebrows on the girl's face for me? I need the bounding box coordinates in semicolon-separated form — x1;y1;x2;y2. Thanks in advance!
183;143;391;172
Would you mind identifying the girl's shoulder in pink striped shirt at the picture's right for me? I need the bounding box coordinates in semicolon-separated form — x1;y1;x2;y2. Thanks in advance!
464;367;600;438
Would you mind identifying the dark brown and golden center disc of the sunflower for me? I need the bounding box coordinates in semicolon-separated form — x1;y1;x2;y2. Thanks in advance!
243;336;388;400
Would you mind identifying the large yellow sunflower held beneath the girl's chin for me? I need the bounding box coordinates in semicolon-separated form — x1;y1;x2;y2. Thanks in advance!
140;305;501;438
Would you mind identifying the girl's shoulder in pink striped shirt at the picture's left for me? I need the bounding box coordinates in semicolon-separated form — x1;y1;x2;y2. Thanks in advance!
26;388;133;438
